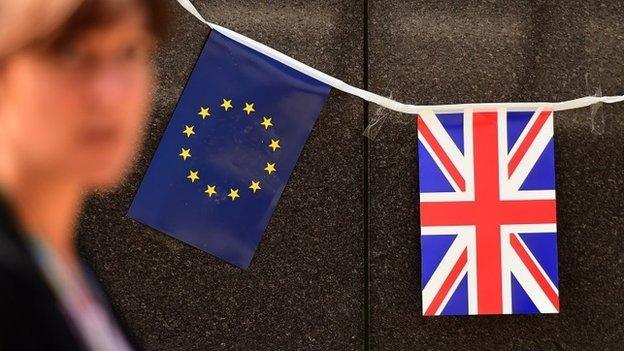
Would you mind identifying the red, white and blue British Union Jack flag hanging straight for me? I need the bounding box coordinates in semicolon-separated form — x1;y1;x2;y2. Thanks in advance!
418;108;559;316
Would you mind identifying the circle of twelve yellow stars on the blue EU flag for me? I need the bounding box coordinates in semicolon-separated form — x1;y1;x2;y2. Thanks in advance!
178;99;282;201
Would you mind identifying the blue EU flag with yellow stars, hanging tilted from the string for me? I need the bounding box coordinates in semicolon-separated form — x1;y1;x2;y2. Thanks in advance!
128;31;330;269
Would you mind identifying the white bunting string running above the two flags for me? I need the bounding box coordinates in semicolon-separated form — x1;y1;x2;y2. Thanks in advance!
177;0;624;114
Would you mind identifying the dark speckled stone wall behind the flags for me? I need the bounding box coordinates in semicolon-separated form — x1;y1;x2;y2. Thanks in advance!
79;0;624;350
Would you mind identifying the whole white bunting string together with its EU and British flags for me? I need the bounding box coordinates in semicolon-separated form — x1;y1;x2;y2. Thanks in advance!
129;0;624;316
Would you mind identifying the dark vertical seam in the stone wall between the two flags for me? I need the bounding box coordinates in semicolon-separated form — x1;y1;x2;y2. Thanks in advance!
362;0;370;350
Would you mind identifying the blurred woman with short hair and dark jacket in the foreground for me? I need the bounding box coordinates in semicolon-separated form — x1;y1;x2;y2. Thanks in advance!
0;0;165;350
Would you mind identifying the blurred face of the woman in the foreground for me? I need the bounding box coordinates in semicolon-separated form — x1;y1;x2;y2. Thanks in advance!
0;11;154;189
